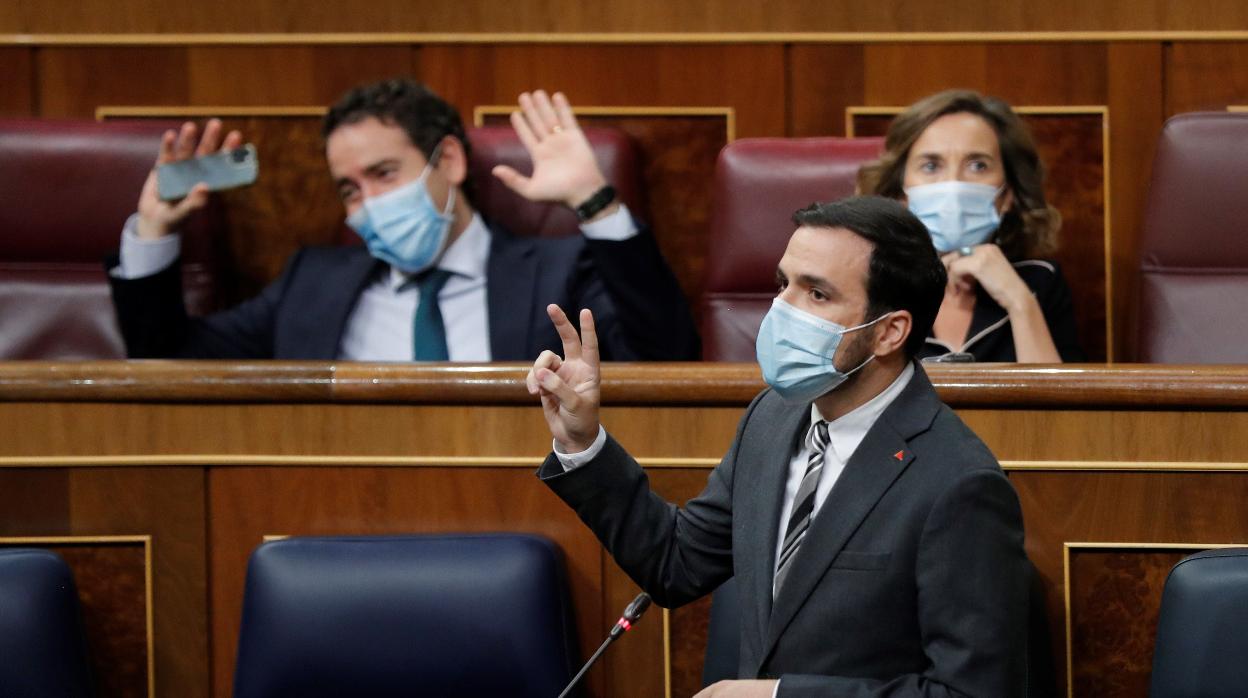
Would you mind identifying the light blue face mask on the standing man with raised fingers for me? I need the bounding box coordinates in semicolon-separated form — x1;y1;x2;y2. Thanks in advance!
755;298;887;402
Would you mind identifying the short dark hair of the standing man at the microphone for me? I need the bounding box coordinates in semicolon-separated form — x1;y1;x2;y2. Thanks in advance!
792;196;947;358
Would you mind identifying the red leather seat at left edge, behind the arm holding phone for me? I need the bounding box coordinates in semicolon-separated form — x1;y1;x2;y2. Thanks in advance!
0;120;220;360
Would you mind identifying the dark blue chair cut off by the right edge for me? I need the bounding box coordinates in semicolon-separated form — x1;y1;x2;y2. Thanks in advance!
1149;548;1248;698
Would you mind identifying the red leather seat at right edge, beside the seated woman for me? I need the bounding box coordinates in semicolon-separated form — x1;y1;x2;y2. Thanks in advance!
1136;112;1248;363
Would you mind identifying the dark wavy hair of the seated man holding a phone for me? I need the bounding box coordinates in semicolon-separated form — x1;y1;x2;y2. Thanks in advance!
321;77;473;201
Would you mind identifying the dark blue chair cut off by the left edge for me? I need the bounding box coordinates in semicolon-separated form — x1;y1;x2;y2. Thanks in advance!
0;548;91;698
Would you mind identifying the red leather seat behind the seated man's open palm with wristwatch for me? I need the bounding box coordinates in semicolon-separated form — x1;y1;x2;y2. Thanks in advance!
341;126;646;245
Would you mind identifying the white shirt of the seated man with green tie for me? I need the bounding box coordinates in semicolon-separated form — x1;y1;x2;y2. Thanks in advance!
110;204;638;362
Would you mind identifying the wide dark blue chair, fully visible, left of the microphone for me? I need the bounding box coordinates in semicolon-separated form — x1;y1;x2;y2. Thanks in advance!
235;534;578;698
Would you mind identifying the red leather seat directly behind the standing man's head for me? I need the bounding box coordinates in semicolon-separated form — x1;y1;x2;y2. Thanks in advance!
701;137;884;361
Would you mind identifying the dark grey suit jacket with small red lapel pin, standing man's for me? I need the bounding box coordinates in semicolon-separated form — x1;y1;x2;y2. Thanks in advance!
539;368;1028;698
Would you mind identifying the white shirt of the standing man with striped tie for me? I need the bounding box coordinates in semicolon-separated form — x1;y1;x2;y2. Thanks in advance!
553;363;915;698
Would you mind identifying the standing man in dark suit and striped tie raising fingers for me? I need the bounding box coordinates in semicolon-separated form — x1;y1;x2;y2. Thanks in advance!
528;197;1028;698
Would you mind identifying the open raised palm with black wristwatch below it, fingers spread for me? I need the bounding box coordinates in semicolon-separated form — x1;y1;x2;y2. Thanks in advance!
493;90;607;214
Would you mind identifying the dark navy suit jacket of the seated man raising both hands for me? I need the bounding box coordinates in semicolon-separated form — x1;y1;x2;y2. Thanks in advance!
109;221;699;361
